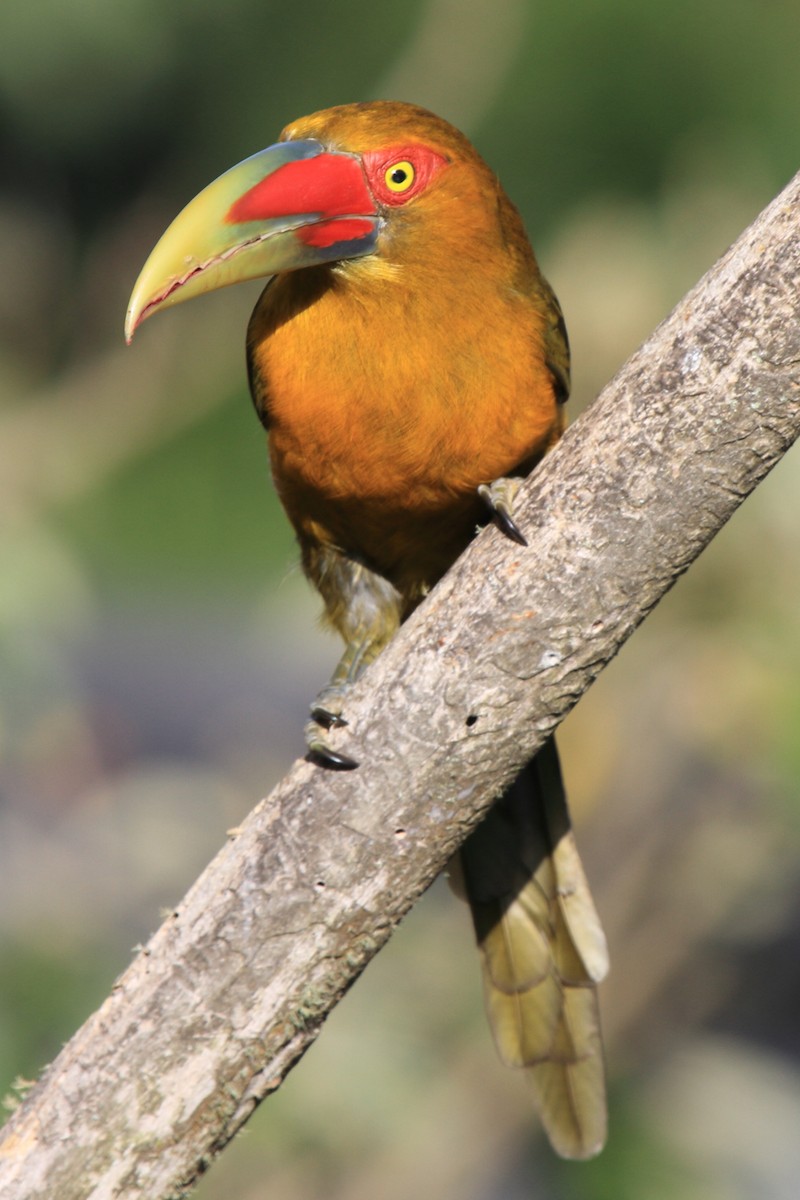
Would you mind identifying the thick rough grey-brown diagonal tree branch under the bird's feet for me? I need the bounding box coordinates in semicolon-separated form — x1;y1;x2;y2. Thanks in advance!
0;175;800;1200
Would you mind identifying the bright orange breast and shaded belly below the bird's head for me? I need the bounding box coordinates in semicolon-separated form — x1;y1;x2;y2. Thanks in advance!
248;252;561;589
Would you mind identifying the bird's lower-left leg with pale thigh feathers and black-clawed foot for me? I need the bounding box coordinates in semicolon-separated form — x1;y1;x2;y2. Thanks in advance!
303;545;401;770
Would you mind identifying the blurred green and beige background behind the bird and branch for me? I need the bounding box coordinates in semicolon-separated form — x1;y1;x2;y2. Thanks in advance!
0;0;800;1200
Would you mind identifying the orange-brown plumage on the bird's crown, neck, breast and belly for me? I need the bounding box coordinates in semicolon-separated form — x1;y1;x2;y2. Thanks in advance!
248;104;561;614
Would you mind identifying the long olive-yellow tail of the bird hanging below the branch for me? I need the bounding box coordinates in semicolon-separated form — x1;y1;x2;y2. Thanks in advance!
461;739;608;1158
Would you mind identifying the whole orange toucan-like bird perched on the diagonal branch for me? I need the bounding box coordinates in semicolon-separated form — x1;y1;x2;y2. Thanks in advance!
125;101;608;1159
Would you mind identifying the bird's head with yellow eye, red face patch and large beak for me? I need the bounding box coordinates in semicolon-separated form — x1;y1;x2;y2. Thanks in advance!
125;101;507;342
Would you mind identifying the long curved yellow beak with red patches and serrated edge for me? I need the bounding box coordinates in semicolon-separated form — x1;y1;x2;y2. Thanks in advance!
125;140;380;343
